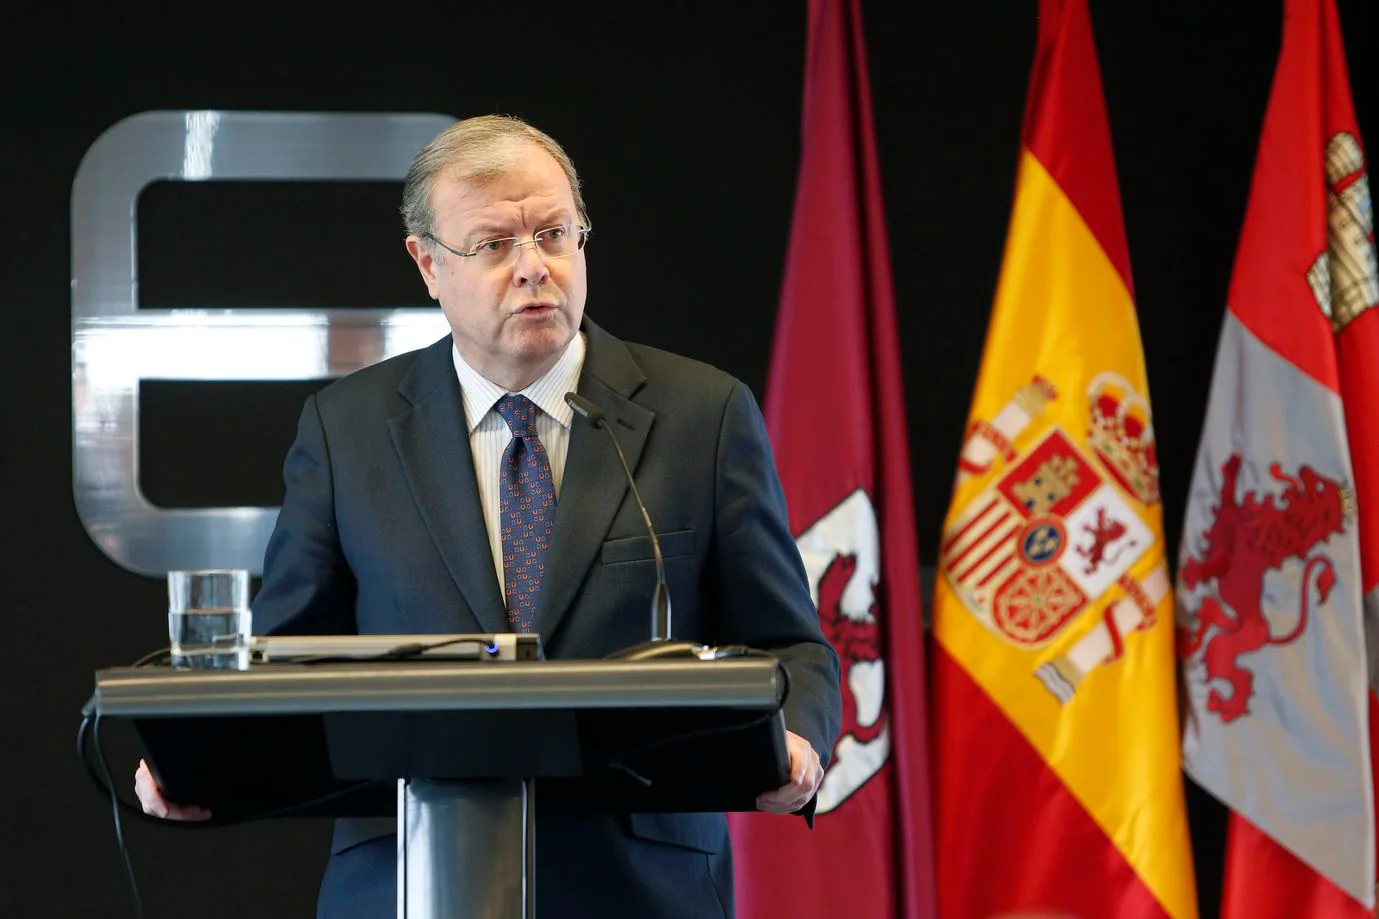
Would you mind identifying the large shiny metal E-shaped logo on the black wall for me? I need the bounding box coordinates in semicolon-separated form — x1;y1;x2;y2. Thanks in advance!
72;110;454;577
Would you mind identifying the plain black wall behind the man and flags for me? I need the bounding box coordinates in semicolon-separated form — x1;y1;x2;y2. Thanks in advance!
0;0;1379;919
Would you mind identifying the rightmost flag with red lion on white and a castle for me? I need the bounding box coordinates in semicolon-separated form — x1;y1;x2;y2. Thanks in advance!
1176;0;1379;919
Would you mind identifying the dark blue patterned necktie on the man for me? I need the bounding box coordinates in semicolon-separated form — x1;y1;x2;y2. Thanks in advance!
495;396;556;632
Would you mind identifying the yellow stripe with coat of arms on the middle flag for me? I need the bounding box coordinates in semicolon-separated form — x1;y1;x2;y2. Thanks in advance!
934;150;1196;916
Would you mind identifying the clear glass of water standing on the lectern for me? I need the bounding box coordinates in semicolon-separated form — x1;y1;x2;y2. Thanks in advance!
168;569;251;671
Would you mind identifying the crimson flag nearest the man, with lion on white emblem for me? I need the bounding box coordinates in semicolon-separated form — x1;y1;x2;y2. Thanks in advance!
732;0;934;919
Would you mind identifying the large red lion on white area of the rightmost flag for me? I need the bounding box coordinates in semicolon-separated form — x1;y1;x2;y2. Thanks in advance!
1178;453;1350;723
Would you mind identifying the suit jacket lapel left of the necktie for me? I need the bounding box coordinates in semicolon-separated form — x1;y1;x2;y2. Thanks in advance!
387;337;507;632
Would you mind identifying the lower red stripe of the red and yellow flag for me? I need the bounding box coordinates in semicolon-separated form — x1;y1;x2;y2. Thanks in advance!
929;643;1168;919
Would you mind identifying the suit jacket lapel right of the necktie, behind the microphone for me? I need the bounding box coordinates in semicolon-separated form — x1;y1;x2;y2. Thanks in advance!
536;319;656;640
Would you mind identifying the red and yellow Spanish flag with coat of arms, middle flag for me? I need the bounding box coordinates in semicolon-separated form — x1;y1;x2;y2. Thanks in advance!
932;0;1197;919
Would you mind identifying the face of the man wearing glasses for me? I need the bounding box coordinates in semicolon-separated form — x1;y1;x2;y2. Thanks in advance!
407;146;587;391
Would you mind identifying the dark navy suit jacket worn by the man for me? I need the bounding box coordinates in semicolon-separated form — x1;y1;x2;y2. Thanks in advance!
254;319;840;919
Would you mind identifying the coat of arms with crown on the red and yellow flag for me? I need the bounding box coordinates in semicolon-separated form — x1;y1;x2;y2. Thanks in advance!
942;373;1169;702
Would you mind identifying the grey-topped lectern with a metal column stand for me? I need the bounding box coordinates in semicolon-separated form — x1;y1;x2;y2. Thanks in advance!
94;655;789;919
